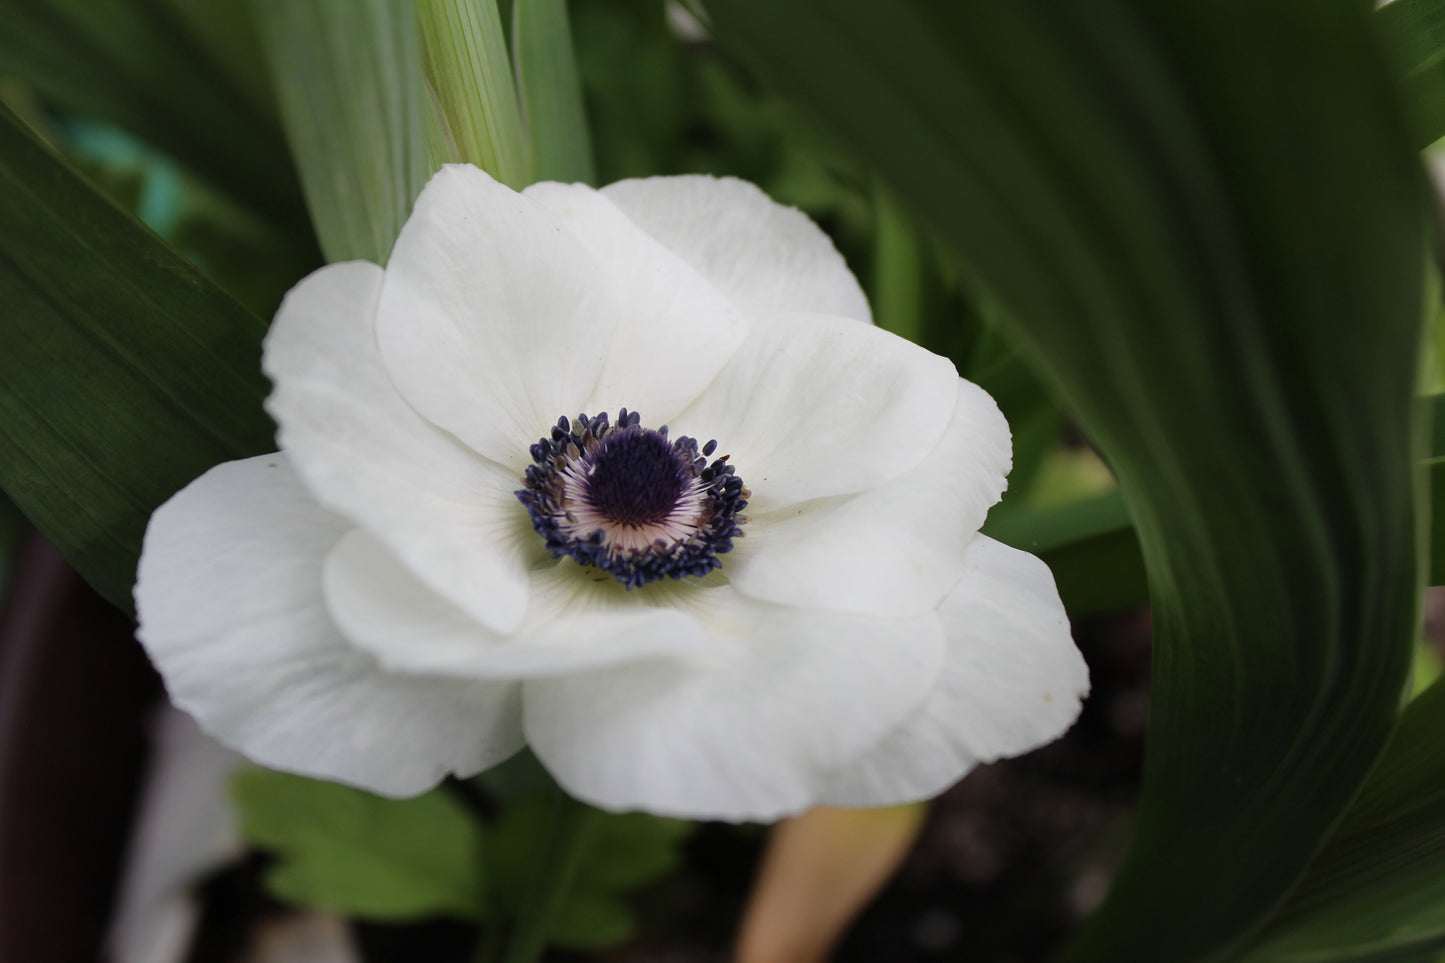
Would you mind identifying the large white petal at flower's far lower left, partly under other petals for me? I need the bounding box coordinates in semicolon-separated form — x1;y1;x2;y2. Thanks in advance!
136;454;522;795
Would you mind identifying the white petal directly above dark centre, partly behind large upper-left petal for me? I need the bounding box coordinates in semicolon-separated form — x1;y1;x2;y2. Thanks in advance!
523;182;747;427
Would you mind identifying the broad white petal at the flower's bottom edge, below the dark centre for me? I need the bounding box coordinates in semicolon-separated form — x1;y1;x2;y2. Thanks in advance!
523;587;942;820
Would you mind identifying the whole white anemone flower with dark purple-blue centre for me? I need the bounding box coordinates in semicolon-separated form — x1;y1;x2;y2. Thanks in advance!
136;166;1088;820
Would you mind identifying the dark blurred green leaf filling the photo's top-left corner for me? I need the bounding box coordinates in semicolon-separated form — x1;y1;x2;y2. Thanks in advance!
0;0;306;231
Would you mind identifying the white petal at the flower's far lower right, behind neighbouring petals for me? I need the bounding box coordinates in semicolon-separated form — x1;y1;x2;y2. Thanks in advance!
822;535;1088;805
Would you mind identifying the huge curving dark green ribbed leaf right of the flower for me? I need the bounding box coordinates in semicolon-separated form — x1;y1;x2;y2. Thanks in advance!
708;0;1426;963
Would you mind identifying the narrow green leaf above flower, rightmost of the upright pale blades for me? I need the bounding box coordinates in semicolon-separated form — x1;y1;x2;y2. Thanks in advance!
512;0;597;184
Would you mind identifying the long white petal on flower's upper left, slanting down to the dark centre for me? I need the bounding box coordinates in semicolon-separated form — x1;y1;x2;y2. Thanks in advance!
264;260;532;632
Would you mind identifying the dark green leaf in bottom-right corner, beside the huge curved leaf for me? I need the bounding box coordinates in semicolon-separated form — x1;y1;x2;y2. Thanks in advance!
1243;673;1445;963
